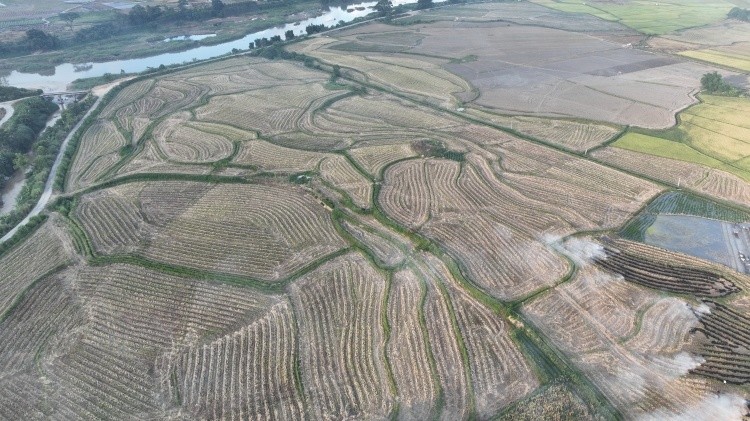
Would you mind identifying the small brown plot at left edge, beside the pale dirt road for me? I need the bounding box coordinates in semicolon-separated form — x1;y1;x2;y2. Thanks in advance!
0;222;72;320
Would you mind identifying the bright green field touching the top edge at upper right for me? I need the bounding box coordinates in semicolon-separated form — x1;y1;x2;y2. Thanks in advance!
532;0;735;35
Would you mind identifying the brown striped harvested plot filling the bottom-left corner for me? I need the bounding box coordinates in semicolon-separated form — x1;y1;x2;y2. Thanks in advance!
0;258;277;419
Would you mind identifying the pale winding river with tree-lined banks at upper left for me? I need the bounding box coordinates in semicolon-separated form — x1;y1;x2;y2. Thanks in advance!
6;0;445;92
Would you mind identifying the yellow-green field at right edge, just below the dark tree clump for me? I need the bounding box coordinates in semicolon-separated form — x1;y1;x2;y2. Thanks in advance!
613;95;750;180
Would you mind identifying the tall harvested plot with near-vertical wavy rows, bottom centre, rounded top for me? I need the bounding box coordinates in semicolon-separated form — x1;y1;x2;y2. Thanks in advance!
290;254;394;419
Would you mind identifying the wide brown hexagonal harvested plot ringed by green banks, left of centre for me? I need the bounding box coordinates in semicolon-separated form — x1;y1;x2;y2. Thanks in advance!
77;183;344;281
